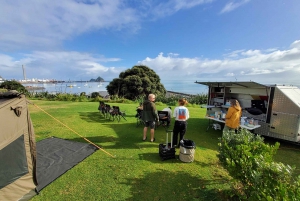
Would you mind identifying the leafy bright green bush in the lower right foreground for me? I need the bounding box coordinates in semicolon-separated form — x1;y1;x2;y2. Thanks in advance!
218;129;300;200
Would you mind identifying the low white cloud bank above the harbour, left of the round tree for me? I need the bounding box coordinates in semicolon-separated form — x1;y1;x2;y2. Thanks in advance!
0;51;125;80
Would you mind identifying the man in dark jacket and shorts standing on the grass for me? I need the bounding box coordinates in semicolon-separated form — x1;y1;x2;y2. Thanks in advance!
142;94;158;142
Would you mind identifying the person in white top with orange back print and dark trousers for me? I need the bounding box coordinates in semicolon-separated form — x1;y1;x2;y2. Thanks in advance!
173;98;190;147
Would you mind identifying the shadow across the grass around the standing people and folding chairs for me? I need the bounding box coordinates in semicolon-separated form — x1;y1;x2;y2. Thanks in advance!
79;112;221;150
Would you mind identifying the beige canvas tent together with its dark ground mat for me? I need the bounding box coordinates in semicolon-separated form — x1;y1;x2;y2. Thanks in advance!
0;92;97;200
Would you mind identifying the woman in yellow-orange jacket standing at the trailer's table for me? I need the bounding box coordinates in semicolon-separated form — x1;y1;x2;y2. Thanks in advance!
223;99;242;134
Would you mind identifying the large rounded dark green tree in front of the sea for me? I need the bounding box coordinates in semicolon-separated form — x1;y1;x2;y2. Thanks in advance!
106;65;166;100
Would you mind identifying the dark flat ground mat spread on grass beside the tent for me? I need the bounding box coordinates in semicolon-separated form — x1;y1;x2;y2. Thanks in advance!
36;137;97;192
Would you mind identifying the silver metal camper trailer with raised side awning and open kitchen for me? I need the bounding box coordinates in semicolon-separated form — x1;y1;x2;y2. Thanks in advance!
195;81;300;143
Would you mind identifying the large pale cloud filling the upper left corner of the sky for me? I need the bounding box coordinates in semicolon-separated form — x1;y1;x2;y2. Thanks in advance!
0;0;139;50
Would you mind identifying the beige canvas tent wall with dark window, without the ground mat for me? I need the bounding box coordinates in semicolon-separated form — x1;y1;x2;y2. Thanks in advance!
0;92;36;200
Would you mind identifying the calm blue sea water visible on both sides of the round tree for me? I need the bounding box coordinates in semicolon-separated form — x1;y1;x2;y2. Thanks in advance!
23;81;208;95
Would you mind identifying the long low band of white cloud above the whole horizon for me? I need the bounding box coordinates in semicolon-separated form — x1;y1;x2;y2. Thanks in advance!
0;41;300;85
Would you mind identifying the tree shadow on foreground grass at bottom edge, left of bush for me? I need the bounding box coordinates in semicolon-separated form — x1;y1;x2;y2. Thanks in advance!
122;169;228;201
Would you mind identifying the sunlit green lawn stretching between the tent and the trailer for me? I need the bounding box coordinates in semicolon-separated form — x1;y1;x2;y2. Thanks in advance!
29;100;300;201
